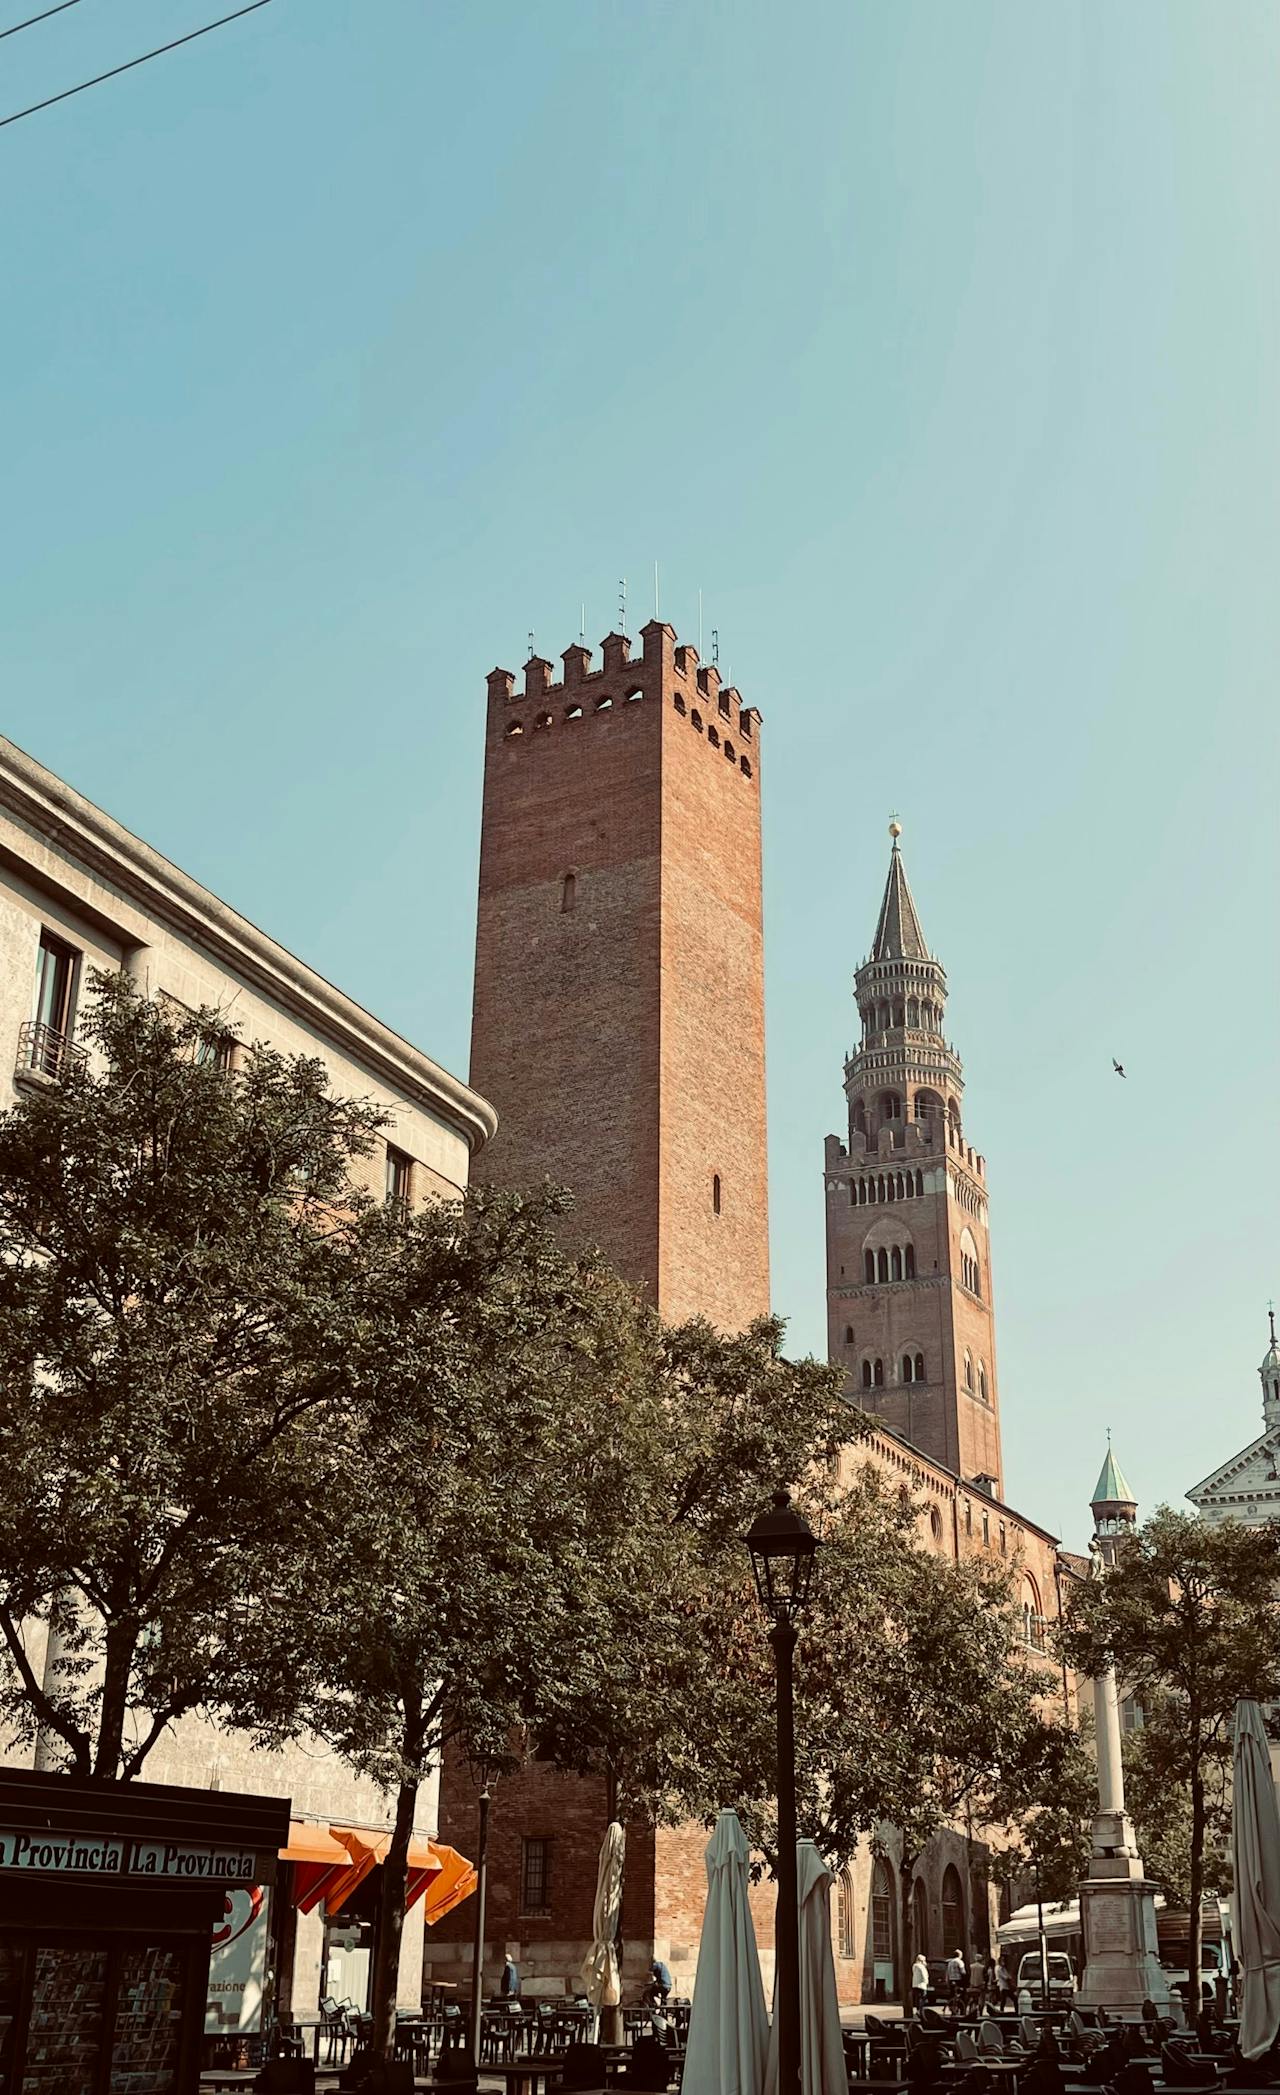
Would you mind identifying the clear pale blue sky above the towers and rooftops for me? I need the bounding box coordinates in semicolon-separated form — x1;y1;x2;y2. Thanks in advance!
0;0;1280;1542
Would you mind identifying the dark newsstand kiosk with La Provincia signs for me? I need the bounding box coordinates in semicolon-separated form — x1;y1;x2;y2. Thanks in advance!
0;1768;289;2095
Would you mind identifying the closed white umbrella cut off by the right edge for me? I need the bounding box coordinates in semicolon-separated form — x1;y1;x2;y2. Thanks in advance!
1240;1701;1280;2059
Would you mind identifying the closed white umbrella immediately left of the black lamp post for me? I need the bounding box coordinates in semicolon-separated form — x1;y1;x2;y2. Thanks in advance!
681;1812;769;2095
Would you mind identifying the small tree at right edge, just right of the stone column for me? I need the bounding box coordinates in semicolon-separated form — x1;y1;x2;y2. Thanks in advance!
1062;1506;1280;1986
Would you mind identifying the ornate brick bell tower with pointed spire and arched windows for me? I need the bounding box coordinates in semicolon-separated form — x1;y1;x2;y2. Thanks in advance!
825;821;1003;1494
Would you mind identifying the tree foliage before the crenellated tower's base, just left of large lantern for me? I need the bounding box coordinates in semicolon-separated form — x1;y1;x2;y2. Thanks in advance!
525;1318;854;1833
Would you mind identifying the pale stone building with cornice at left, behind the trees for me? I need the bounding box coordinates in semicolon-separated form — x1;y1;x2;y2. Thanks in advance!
0;740;494;2013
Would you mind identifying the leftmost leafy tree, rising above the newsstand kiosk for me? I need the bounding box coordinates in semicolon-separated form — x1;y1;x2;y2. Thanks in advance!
0;974;381;1779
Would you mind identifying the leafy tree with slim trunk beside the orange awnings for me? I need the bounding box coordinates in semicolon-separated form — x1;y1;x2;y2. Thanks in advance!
278;1188;658;2057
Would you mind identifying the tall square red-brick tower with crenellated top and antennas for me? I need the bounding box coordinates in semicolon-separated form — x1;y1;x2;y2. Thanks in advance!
427;620;769;1999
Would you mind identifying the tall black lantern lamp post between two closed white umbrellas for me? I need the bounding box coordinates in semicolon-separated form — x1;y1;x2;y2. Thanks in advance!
746;1492;817;2095
